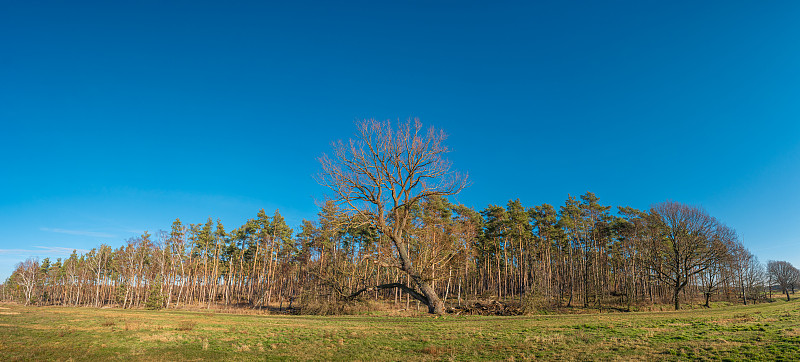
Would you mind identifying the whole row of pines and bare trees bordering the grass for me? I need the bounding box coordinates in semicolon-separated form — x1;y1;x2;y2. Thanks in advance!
0;120;800;314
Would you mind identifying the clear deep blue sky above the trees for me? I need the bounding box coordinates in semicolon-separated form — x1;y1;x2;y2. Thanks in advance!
0;1;800;280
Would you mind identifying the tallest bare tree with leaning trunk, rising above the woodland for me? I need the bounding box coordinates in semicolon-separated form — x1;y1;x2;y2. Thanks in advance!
320;119;467;314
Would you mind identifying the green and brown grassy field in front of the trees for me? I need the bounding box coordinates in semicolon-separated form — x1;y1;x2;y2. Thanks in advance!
0;301;800;361
